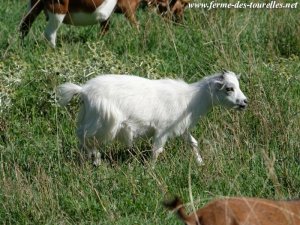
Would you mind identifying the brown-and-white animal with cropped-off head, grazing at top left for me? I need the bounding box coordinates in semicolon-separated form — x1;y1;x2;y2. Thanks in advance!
20;0;140;47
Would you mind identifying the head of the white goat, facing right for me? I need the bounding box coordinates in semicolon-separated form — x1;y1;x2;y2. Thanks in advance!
213;71;248;110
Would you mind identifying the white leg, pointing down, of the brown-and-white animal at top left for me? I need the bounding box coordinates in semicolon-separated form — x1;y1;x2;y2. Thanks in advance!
45;11;66;48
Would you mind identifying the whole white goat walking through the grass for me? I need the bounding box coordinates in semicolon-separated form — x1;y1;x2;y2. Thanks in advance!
57;71;247;165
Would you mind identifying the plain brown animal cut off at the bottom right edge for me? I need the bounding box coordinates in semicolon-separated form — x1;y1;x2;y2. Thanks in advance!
164;197;300;225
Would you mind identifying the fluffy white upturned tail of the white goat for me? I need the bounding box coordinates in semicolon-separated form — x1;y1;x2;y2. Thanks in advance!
56;83;82;106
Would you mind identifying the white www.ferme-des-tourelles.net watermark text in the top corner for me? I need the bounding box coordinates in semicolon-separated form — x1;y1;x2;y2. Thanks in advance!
188;1;299;10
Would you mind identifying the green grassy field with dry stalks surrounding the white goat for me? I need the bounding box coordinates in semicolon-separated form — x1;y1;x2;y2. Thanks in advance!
0;0;300;225
